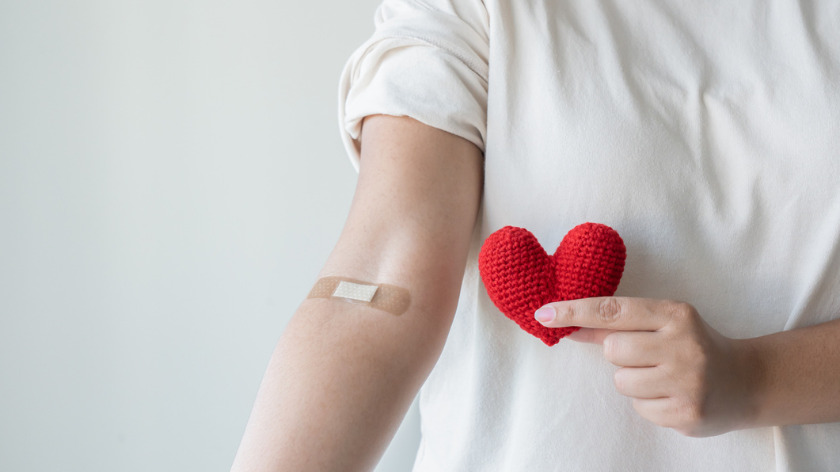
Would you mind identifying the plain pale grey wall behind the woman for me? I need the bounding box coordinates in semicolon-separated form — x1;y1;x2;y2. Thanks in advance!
0;0;419;472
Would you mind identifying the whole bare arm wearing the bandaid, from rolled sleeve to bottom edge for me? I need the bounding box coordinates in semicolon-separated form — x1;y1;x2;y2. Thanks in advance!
232;116;482;472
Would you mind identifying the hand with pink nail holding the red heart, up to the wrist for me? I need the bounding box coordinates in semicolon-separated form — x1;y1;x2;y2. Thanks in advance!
535;297;756;437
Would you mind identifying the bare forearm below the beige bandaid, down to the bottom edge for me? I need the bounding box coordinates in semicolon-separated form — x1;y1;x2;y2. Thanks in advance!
228;299;451;471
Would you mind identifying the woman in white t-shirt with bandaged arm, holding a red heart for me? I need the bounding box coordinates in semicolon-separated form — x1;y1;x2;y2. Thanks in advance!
234;0;840;471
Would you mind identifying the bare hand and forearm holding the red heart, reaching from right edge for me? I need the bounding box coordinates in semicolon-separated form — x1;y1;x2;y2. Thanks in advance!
535;297;840;437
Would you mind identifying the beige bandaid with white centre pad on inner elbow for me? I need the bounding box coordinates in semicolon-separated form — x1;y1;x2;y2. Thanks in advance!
306;277;411;315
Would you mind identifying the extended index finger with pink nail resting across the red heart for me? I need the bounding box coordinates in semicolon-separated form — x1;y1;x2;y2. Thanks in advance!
534;297;674;331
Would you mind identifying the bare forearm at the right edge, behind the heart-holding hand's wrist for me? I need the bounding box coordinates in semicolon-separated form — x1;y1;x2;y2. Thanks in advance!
742;320;840;427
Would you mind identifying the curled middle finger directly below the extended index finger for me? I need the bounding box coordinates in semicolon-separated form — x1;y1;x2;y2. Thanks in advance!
599;330;666;367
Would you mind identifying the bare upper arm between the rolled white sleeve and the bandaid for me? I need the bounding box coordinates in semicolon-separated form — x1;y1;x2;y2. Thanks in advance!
322;115;483;318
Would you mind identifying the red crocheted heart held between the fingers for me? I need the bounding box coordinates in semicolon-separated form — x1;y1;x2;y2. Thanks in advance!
478;223;626;346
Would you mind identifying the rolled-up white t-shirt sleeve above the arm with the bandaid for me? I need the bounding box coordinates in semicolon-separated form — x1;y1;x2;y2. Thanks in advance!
338;0;489;170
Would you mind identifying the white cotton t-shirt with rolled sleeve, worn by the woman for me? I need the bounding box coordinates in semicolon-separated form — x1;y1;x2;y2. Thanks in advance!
339;0;840;472
